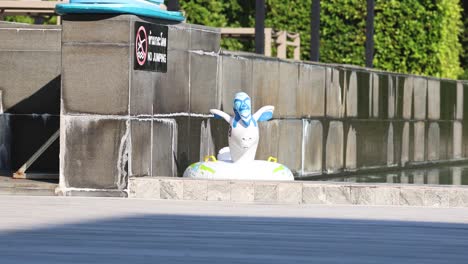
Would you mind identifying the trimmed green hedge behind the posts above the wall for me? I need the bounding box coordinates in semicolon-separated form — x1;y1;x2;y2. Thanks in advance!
175;0;468;78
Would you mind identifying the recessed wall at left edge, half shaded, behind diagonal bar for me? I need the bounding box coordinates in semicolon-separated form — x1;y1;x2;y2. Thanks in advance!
0;23;61;175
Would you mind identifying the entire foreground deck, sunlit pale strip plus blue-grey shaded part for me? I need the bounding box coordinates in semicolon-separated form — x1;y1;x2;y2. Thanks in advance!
0;196;468;264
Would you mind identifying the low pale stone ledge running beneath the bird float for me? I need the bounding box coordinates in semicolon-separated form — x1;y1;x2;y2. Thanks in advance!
128;177;468;207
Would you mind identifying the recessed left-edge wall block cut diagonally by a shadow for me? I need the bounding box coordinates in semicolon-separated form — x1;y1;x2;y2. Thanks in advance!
0;52;61;114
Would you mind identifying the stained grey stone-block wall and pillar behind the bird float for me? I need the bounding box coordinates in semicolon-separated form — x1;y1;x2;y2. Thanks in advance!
6;15;468;196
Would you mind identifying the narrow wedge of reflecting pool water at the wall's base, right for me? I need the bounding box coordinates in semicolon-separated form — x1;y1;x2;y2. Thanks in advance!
310;164;468;185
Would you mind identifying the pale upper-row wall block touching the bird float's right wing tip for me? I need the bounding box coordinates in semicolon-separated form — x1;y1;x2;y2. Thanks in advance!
276;62;300;118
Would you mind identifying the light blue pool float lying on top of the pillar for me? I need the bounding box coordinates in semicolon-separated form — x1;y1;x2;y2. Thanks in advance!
55;0;185;21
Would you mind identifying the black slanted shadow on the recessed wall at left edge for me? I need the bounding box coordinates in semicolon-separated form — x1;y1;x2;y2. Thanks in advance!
0;75;61;174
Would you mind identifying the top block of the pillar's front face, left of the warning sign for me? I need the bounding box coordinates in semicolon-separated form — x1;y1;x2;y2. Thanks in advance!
59;16;130;45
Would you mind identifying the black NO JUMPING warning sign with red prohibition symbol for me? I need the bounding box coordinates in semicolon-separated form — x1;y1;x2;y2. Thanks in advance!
133;22;168;72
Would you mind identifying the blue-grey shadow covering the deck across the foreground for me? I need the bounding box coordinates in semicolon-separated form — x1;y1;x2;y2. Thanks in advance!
0;214;468;264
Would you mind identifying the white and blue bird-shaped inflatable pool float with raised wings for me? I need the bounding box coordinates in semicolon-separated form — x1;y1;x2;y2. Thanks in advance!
183;92;294;181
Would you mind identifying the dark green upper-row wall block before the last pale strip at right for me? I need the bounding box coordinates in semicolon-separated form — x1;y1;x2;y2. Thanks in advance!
440;80;456;120
